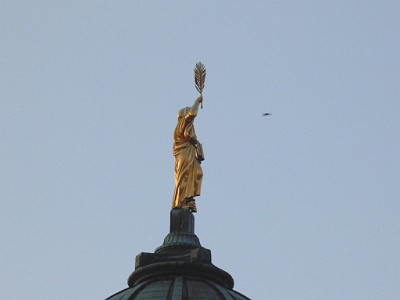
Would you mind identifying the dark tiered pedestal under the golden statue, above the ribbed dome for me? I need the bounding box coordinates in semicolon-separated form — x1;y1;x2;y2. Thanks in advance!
128;208;233;289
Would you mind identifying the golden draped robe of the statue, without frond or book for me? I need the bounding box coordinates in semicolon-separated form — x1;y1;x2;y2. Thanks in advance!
172;103;203;208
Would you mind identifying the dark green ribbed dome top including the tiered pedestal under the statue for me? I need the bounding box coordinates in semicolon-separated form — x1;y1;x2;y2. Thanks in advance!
106;208;250;300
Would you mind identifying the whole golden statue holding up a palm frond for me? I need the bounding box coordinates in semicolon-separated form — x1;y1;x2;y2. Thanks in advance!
172;63;206;212
